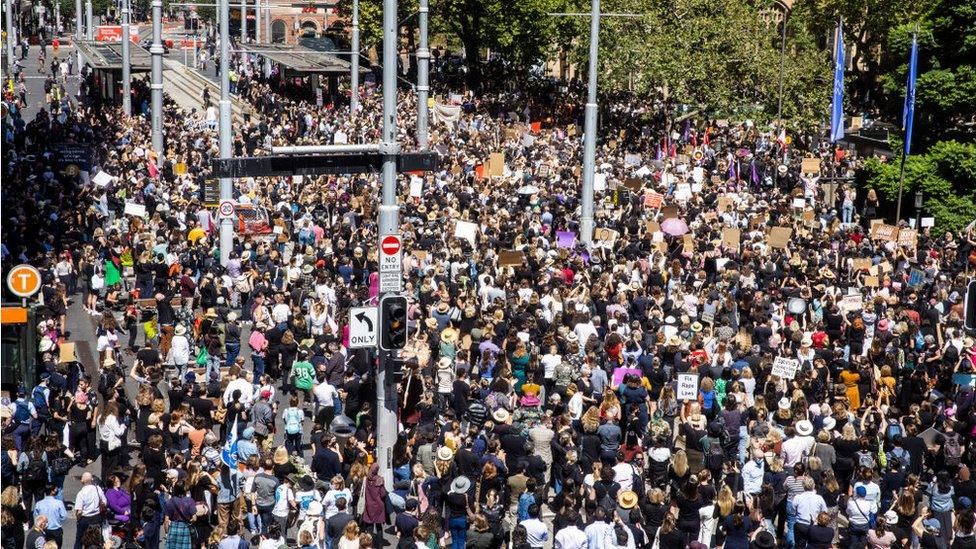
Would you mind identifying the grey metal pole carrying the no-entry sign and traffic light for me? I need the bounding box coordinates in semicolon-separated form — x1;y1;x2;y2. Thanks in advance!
378;0;400;490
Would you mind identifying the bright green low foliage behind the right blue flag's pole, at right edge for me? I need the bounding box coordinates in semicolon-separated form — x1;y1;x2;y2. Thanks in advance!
864;141;976;233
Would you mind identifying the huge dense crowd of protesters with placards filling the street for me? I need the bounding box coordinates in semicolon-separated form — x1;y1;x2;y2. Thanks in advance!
0;31;976;549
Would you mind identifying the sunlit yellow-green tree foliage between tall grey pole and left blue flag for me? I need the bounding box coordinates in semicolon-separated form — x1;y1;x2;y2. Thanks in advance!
575;0;831;127
